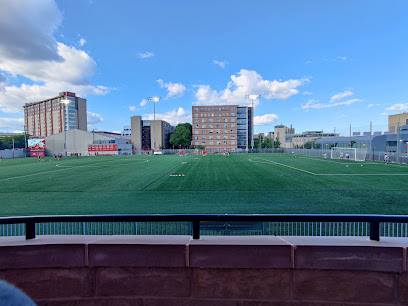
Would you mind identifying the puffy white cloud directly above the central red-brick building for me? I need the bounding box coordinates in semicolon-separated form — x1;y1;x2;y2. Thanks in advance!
193;69;309;106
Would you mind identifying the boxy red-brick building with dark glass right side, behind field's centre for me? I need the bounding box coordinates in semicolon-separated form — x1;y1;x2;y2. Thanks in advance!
192;105;253;152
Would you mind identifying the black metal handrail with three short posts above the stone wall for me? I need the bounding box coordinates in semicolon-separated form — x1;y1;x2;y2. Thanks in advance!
0;214;408;241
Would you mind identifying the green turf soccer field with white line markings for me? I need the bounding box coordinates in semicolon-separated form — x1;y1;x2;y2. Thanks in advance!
0;154;408;216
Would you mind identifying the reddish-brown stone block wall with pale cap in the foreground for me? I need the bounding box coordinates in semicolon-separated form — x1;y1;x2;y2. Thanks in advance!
0;236;408;305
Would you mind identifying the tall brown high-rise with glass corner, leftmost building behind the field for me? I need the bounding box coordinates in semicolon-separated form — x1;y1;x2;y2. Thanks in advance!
23;92;88;137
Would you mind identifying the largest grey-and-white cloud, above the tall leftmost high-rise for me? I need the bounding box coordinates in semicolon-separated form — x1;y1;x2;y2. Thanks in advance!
0;0;112;113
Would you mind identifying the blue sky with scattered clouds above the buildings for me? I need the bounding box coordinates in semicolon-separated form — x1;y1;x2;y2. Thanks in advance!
0;0;408;133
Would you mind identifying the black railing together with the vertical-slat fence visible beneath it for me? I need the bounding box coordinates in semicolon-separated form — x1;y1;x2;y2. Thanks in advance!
0;214;408;241
